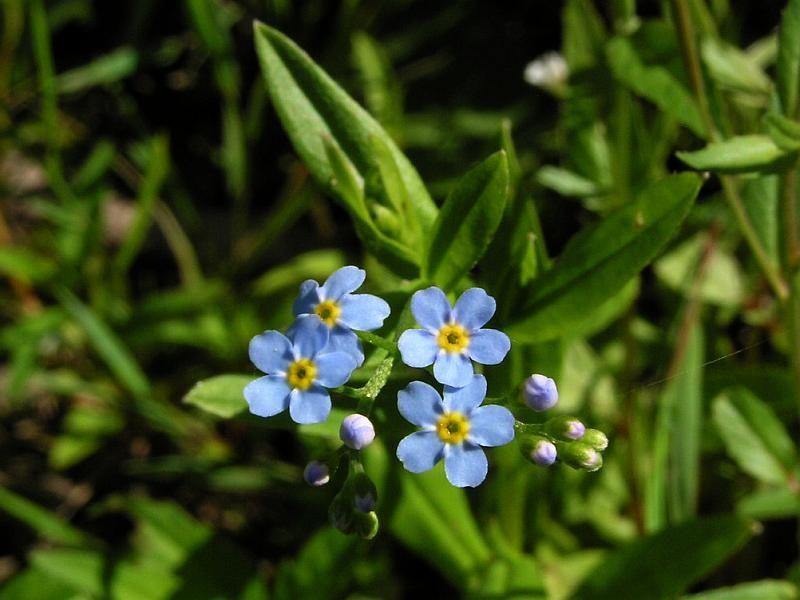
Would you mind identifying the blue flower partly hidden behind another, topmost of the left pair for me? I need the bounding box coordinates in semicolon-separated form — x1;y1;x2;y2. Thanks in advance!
294;266;391;366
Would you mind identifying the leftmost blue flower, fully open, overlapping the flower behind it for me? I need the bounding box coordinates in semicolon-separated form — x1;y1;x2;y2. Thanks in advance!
244;316;357;423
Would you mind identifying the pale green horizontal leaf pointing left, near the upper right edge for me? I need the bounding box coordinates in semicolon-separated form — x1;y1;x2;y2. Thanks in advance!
676;134;786;173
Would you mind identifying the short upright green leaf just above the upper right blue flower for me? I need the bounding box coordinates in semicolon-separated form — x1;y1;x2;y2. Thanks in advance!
424;151;509;290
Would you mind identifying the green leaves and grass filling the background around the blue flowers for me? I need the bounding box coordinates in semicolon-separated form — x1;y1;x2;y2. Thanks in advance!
0;0;800;600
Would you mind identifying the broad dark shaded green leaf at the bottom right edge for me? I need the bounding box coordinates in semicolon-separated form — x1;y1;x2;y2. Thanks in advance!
573;516;752;600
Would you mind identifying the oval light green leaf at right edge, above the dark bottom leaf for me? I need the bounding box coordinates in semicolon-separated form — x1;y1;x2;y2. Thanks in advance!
713;388;796;484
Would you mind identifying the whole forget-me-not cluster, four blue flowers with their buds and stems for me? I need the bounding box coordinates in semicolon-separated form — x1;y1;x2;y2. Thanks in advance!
244;266;608;538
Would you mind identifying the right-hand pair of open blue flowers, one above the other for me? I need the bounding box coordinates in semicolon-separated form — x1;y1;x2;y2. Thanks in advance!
397;287;514;487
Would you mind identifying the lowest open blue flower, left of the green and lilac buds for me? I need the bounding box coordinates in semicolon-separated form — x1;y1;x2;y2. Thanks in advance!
397;375;514;487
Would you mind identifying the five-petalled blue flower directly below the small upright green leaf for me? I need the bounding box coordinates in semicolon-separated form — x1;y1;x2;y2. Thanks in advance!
397;287;511;387
